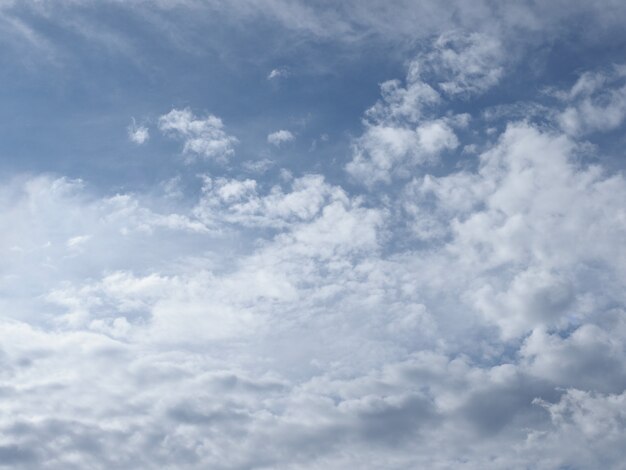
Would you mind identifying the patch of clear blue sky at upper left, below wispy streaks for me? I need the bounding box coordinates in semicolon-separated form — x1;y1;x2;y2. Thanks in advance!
0;4;401;196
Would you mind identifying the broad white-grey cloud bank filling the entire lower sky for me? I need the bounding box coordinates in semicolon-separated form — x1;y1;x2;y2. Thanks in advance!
0;114;626;469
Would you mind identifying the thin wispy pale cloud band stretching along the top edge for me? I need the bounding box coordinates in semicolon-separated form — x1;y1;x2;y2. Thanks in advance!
0;0;626;79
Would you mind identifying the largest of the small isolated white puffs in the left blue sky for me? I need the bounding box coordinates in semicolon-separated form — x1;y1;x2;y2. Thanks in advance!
159;108;238;162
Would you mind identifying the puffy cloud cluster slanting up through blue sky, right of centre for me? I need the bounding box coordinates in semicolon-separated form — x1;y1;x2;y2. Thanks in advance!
346;33;504;186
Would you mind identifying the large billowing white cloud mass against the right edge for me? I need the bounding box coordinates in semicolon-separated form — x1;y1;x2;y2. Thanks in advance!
405;124;626;338
